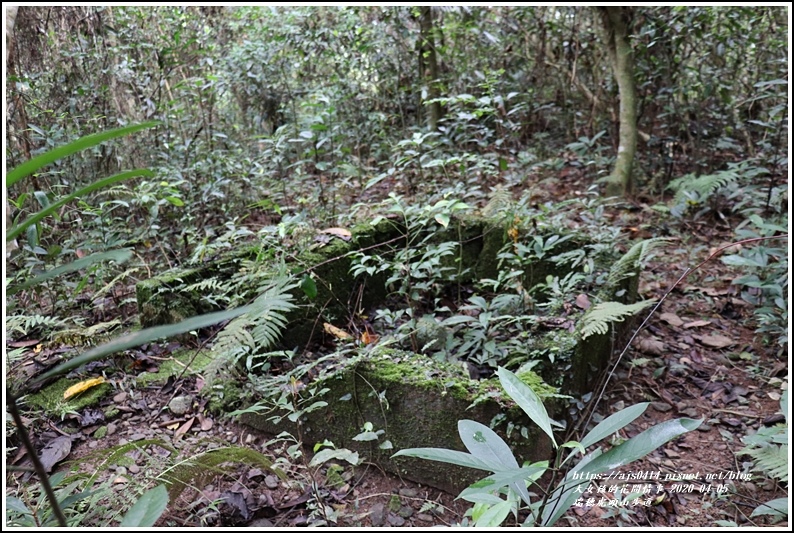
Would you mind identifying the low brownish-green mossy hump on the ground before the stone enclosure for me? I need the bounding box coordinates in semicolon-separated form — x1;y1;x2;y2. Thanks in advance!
158;446;286;501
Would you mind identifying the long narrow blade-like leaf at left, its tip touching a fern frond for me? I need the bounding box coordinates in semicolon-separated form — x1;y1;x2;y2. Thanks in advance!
30;303;260;385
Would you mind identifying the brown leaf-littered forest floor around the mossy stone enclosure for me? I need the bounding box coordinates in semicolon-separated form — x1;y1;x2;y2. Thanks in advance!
7;168;788;528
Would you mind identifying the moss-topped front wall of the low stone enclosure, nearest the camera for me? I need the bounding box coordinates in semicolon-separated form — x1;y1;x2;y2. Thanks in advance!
241;350;556;492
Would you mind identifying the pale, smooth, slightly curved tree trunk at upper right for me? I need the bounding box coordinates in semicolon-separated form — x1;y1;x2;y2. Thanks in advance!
598;7;637;196
